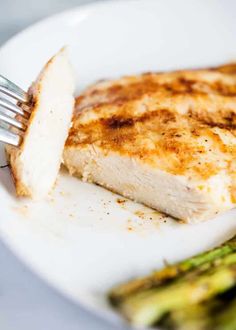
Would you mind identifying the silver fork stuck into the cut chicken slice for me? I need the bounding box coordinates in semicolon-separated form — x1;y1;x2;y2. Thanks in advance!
0;75;30;146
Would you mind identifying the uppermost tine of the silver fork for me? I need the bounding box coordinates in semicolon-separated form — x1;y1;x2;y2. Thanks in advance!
0;75;28;103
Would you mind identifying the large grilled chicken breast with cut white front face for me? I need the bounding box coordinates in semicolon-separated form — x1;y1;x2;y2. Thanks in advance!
64;65;236;222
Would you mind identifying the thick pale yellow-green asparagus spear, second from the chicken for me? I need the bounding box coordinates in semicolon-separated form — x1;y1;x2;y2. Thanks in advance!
120;253;236;326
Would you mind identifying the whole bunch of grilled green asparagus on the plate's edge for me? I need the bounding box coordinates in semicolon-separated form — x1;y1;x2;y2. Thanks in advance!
109;236;236;330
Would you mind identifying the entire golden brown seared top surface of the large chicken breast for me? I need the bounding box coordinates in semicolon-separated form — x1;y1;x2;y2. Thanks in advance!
66;64;236;188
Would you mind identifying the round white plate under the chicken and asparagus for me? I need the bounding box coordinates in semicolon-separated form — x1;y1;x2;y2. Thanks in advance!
0;0;236;328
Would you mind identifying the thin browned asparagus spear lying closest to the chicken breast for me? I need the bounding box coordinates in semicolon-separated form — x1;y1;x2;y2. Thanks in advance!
109;236;236;305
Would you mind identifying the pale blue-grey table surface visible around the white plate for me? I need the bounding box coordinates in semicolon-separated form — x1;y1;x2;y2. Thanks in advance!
0;0;125;330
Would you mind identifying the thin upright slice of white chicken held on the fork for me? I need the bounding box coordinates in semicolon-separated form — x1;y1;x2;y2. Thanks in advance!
7;49;74;198
